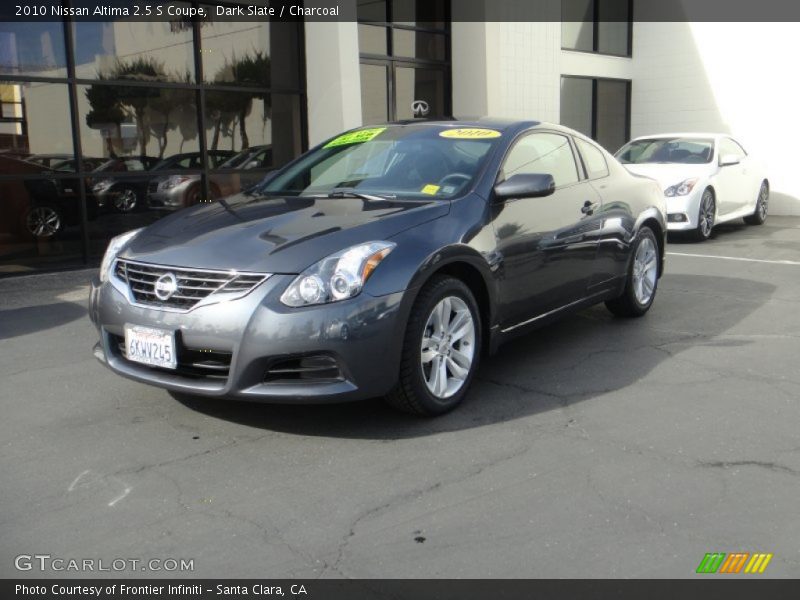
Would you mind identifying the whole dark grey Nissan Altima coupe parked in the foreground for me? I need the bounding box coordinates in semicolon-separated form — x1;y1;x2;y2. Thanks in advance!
90;120;666;415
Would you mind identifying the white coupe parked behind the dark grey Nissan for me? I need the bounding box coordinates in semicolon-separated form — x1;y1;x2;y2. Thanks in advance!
615;133;769;241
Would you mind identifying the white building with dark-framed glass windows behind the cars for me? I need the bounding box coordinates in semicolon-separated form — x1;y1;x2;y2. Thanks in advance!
0;0;800;275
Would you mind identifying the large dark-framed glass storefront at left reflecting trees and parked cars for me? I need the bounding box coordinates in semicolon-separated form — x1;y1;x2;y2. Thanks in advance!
0;9;306;276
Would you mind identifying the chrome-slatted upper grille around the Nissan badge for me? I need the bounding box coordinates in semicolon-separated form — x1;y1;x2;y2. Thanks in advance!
114;259;269;311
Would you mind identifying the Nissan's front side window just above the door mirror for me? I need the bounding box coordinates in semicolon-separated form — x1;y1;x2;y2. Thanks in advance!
503;133;578;187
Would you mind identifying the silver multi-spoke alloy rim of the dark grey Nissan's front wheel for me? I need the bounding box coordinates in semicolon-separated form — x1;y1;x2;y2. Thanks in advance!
420;296;475;399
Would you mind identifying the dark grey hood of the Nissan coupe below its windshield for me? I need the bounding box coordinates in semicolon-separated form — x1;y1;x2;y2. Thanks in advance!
120;194;450;273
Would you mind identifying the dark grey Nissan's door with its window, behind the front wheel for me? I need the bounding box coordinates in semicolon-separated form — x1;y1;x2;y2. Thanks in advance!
492;131;600;327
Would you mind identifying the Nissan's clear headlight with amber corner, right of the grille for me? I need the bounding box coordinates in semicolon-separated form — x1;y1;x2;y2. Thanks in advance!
281;242;397;308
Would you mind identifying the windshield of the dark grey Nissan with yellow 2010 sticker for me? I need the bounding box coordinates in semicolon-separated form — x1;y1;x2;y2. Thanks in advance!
254;124;502;198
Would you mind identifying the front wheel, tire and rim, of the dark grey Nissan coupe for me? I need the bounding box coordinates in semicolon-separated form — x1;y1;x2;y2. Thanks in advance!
386;276;481;416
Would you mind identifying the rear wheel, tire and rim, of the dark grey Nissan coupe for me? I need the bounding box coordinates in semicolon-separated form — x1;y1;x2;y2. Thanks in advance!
606;225;659;317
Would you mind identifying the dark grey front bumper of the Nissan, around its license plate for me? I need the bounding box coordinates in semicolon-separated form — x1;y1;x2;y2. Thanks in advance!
89;275;407;403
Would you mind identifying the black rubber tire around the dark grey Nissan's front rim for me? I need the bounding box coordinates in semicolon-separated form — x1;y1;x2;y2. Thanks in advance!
386;276;482;416
